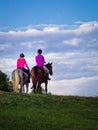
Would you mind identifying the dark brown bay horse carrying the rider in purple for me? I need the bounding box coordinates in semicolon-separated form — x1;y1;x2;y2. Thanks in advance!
31;63;53;94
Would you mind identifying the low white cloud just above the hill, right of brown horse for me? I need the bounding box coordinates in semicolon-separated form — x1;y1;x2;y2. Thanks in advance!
48;76;98;96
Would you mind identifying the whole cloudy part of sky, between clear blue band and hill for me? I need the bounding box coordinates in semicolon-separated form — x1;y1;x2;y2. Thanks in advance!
0;22;98;95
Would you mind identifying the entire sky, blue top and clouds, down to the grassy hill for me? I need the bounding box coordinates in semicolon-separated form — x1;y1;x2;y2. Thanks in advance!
0;0;98;96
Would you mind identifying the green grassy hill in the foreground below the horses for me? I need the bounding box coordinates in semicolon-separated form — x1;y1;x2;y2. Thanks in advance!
0;92;98;130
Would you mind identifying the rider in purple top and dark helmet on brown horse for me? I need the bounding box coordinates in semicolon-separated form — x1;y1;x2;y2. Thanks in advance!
35;49;50;80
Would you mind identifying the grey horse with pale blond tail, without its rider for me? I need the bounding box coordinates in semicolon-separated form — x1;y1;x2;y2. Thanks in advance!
12;69;28;93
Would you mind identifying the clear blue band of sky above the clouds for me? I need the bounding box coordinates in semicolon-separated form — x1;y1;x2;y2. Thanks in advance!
0;0;98;28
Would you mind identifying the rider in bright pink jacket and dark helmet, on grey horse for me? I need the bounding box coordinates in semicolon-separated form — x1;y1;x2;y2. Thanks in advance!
17;53;30;83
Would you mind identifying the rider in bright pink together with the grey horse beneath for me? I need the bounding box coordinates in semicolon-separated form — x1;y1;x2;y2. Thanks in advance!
12;53;30;92
